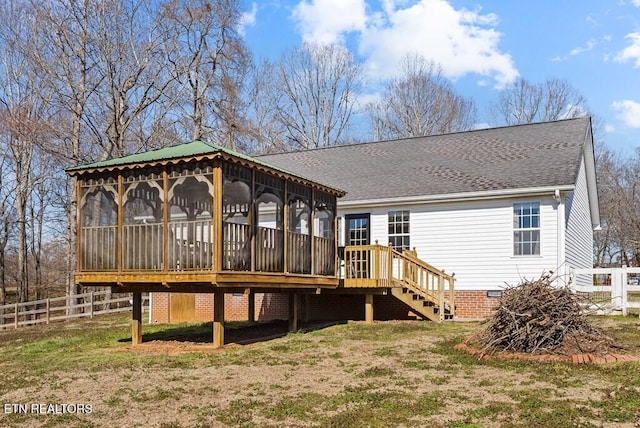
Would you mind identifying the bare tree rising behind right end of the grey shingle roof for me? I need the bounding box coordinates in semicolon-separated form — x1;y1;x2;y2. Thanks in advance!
491;78;588;125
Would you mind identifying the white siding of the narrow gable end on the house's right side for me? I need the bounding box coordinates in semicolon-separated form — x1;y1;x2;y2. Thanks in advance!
565;162;593;286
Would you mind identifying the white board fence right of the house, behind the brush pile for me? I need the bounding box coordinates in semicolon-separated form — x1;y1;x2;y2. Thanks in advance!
571;266;640;315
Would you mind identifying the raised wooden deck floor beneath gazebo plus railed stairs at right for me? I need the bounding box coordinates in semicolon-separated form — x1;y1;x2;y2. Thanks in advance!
76;244;455;321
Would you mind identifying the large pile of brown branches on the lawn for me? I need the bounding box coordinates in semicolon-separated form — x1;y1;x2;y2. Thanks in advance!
479;275;613;354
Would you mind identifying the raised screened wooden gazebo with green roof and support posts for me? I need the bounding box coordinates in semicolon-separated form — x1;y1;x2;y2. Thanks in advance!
67;141;344;347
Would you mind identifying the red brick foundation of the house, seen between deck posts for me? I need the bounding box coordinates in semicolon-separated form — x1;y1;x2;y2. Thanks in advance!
151;291;498;323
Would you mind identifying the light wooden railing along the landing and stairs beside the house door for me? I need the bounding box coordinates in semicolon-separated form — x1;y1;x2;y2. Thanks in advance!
341;244;455;308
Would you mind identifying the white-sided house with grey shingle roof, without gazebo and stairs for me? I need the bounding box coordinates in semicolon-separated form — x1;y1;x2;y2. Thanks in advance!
259;117;600;318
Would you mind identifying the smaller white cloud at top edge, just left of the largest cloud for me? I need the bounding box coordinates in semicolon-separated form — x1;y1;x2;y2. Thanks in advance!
292;0;367;43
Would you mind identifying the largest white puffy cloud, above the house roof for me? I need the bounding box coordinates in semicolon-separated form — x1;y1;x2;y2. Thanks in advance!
360;0;518;87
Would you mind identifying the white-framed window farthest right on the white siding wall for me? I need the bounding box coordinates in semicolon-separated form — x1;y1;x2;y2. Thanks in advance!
513;202;540;256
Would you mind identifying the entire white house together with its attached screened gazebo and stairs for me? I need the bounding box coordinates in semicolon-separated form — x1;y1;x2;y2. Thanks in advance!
68;118;600;344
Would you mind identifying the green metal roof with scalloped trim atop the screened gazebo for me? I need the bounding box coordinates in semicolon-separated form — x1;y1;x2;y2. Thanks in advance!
66;140;345;195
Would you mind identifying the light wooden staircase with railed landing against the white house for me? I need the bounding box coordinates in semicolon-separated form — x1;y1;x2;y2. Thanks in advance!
344;243;455;322
